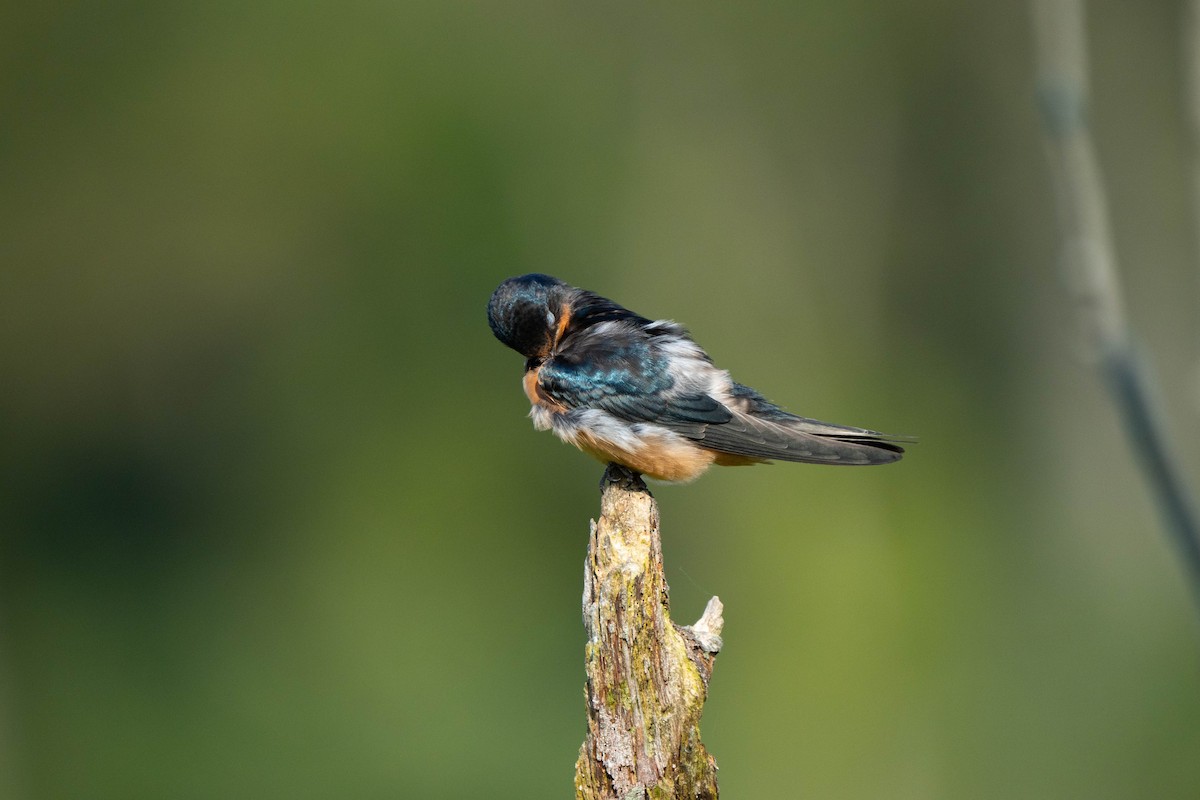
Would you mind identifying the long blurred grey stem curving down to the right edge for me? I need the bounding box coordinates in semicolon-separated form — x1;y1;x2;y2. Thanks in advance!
1032;0;1200;603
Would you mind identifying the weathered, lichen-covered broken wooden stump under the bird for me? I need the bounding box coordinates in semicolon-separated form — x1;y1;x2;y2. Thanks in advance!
575;464;724;800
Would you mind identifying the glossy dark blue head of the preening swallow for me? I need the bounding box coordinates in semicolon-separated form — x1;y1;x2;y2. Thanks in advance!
487;273;574;359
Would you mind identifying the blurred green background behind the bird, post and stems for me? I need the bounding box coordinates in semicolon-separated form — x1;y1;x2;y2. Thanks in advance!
0;0;1200;800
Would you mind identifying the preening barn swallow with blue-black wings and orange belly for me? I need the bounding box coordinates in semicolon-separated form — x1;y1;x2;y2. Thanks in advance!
487;275;912;482
